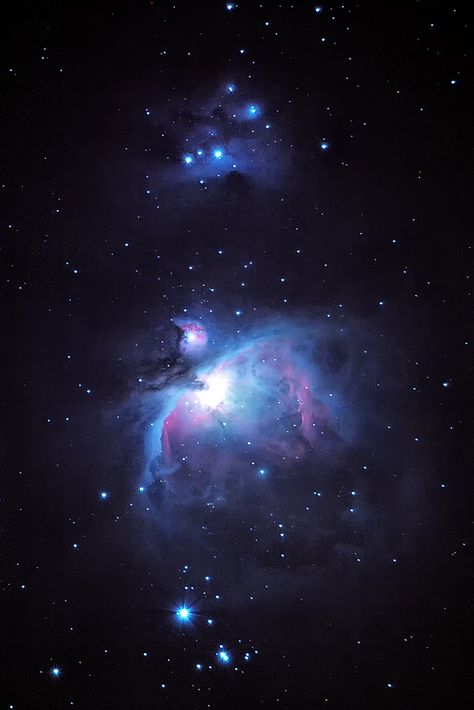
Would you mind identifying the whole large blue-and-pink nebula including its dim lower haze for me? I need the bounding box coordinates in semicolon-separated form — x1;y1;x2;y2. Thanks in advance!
117;314;407;612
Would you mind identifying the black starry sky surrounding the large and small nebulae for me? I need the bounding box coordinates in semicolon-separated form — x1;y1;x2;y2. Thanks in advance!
0;2;472;710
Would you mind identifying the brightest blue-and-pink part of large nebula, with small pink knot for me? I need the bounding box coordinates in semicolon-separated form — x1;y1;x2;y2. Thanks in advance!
152;323;332;484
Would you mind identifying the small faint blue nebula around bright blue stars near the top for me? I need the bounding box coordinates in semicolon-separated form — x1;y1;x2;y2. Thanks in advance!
146;82;294;193
